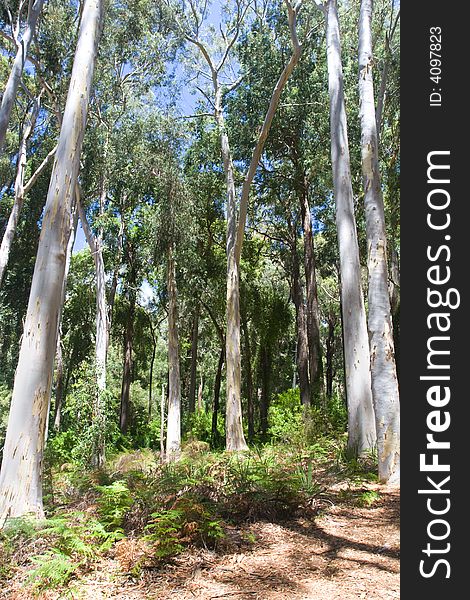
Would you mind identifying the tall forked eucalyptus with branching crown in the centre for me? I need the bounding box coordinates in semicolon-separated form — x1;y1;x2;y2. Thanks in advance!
174;0;302;451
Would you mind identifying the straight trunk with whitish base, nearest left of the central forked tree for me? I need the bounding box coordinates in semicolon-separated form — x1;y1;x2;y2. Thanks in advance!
166;245;181;462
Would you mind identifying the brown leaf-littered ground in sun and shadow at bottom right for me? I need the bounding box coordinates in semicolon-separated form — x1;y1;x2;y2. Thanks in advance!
4;474;400;600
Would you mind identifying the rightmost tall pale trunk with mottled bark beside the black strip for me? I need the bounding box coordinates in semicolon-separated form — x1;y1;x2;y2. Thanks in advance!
359;0;400;482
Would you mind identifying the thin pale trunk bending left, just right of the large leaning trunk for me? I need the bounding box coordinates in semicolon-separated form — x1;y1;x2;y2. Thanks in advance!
76;190;108;468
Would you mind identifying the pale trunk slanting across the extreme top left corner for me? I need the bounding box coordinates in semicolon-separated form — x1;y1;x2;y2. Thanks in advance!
0;0;43;156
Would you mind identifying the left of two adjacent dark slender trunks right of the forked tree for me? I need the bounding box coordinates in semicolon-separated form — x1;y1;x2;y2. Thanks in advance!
291;228;310;406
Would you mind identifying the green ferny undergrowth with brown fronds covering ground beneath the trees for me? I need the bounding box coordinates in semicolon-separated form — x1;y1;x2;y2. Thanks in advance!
0;437;379;595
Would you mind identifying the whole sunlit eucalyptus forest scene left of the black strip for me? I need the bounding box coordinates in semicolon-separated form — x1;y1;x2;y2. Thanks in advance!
0;0;400;600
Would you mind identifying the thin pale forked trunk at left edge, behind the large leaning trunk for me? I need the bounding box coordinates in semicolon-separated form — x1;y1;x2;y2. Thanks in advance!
0;98;57;285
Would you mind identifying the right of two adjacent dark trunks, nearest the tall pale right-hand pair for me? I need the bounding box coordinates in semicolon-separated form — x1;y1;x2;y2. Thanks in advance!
300;182;323;404
